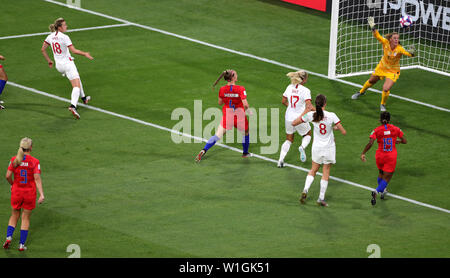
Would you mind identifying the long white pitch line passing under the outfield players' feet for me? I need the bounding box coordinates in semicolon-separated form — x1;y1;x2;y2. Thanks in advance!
8;81;450;213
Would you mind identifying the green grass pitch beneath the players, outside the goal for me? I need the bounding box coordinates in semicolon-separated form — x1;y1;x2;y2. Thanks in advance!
0;0;450;258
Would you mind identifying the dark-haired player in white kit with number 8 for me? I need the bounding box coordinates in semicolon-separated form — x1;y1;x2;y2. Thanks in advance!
292;95;347;207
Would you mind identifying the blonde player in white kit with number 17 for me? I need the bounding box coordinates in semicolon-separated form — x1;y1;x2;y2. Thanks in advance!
277;70;315;168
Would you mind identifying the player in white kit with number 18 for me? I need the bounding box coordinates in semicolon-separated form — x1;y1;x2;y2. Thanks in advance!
41;18;94;119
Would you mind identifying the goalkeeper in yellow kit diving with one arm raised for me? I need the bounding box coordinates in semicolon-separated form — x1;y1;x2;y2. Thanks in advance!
352;17;416;111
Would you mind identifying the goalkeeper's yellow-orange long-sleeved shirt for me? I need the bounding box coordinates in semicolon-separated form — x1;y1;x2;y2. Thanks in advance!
373;30;412;73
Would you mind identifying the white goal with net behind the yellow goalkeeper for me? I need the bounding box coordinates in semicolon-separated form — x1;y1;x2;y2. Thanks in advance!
328;0;450;78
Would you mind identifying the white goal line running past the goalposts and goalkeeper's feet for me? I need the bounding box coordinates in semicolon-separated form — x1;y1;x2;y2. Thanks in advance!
44;0;450;112
